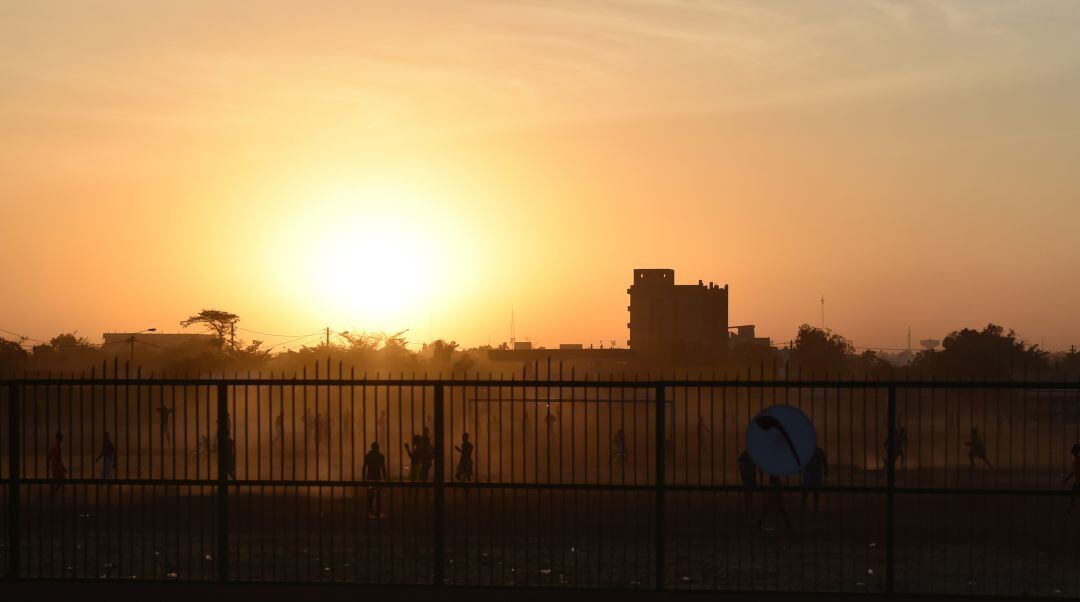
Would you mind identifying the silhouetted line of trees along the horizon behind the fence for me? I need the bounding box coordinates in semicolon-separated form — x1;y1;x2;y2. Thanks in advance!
0;309;1080;379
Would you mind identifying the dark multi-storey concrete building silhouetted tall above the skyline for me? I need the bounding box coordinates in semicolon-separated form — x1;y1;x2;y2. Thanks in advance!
626;269;728;360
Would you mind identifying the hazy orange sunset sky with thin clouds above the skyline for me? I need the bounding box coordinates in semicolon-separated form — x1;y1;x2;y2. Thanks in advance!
0;0;1080;348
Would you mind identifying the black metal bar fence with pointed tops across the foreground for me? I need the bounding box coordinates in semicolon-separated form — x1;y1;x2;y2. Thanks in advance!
0;370;1080;597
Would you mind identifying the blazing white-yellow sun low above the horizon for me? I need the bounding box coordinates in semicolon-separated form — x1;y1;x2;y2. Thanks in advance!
272;180;459;332
